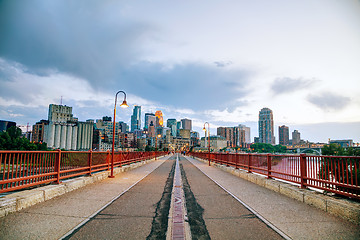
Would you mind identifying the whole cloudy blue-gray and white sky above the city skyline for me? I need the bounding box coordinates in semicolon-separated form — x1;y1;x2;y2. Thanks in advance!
0;0;360;142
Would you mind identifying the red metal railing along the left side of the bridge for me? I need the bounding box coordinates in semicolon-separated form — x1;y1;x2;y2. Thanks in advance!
0;150;166;193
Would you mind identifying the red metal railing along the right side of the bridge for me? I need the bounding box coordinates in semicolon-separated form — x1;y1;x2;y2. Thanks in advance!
189;152;360;199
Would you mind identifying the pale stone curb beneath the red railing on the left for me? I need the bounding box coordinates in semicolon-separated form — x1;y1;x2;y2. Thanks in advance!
0;158;155;217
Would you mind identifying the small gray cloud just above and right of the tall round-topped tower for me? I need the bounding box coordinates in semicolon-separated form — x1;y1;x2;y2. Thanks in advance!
270;77;317;94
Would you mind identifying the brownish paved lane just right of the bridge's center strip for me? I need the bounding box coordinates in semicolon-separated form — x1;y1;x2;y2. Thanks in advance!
180;157;283;240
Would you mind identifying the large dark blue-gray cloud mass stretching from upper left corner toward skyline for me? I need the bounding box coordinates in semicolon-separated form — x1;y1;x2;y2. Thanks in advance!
0;1;250;109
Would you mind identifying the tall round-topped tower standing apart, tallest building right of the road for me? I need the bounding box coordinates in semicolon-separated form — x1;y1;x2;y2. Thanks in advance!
259;108;275;144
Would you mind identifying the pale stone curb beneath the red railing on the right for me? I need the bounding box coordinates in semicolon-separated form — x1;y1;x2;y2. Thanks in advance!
193;157;360;225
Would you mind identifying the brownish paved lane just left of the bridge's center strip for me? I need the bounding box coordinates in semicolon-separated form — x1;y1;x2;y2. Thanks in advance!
66;155;175;240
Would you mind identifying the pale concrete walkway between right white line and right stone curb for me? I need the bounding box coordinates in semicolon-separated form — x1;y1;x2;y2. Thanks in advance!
186;157;360;239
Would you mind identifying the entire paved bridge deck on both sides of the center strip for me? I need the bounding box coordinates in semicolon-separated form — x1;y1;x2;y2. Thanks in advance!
0;157;360;239
